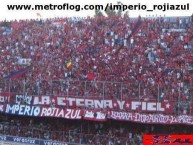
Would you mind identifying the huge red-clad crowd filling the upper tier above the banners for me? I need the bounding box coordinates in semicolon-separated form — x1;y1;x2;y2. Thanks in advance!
0;17;193;101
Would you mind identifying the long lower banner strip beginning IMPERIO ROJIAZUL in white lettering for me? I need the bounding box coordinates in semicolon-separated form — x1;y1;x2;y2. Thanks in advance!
3;104;193;125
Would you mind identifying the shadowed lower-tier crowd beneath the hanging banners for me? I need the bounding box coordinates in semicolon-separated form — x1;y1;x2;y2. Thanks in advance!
0;114;192;145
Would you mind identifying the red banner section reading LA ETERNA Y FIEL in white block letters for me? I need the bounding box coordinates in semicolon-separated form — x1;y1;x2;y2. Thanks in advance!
30;96;174;113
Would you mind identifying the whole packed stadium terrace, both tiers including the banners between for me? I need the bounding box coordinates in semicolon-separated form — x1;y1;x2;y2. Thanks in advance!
0;15;193;145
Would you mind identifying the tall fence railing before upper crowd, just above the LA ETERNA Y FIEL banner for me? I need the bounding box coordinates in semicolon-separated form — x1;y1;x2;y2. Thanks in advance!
0;79;193;114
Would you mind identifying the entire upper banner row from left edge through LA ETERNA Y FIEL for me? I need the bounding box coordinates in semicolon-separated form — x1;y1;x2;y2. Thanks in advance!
0;93;190;114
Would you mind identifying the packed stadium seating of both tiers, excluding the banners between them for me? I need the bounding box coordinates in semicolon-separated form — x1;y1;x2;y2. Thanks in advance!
0;17;193;145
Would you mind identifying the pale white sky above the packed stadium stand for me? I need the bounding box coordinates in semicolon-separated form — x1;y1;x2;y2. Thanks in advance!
0;0;193;20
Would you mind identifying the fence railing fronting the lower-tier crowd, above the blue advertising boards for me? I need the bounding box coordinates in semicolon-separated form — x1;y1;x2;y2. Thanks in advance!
0;123;137;145
